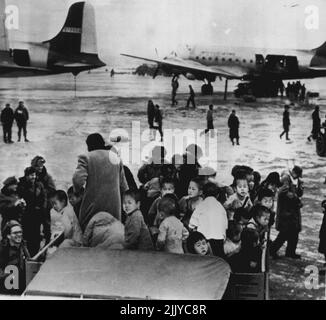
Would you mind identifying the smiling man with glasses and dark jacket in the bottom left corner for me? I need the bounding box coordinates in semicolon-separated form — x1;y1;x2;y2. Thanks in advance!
0;221;30;295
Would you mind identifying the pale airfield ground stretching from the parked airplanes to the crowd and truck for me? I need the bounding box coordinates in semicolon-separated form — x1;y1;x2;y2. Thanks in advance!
0;74;326;299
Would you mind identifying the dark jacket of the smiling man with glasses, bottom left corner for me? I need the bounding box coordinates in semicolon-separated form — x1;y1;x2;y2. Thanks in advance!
0;239;30;294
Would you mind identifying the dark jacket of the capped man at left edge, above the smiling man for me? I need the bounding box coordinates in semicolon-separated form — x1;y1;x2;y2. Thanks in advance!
0;187;23;230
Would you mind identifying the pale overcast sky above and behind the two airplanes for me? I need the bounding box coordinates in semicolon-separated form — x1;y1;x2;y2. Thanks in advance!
7;0;326;65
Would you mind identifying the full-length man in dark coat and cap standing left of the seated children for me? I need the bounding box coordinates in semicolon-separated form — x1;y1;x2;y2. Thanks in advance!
18;167;51;256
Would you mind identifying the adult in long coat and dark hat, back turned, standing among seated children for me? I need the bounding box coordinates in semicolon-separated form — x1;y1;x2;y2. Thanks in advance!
73;134;128;231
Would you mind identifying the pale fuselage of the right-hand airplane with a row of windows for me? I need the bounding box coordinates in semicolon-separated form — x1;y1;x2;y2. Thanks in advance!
180;47;326;82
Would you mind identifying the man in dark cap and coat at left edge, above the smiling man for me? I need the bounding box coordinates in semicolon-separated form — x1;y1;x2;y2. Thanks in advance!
0;177;26;230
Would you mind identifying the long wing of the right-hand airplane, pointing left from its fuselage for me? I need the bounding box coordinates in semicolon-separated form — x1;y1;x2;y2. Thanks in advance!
121;54;245;79
